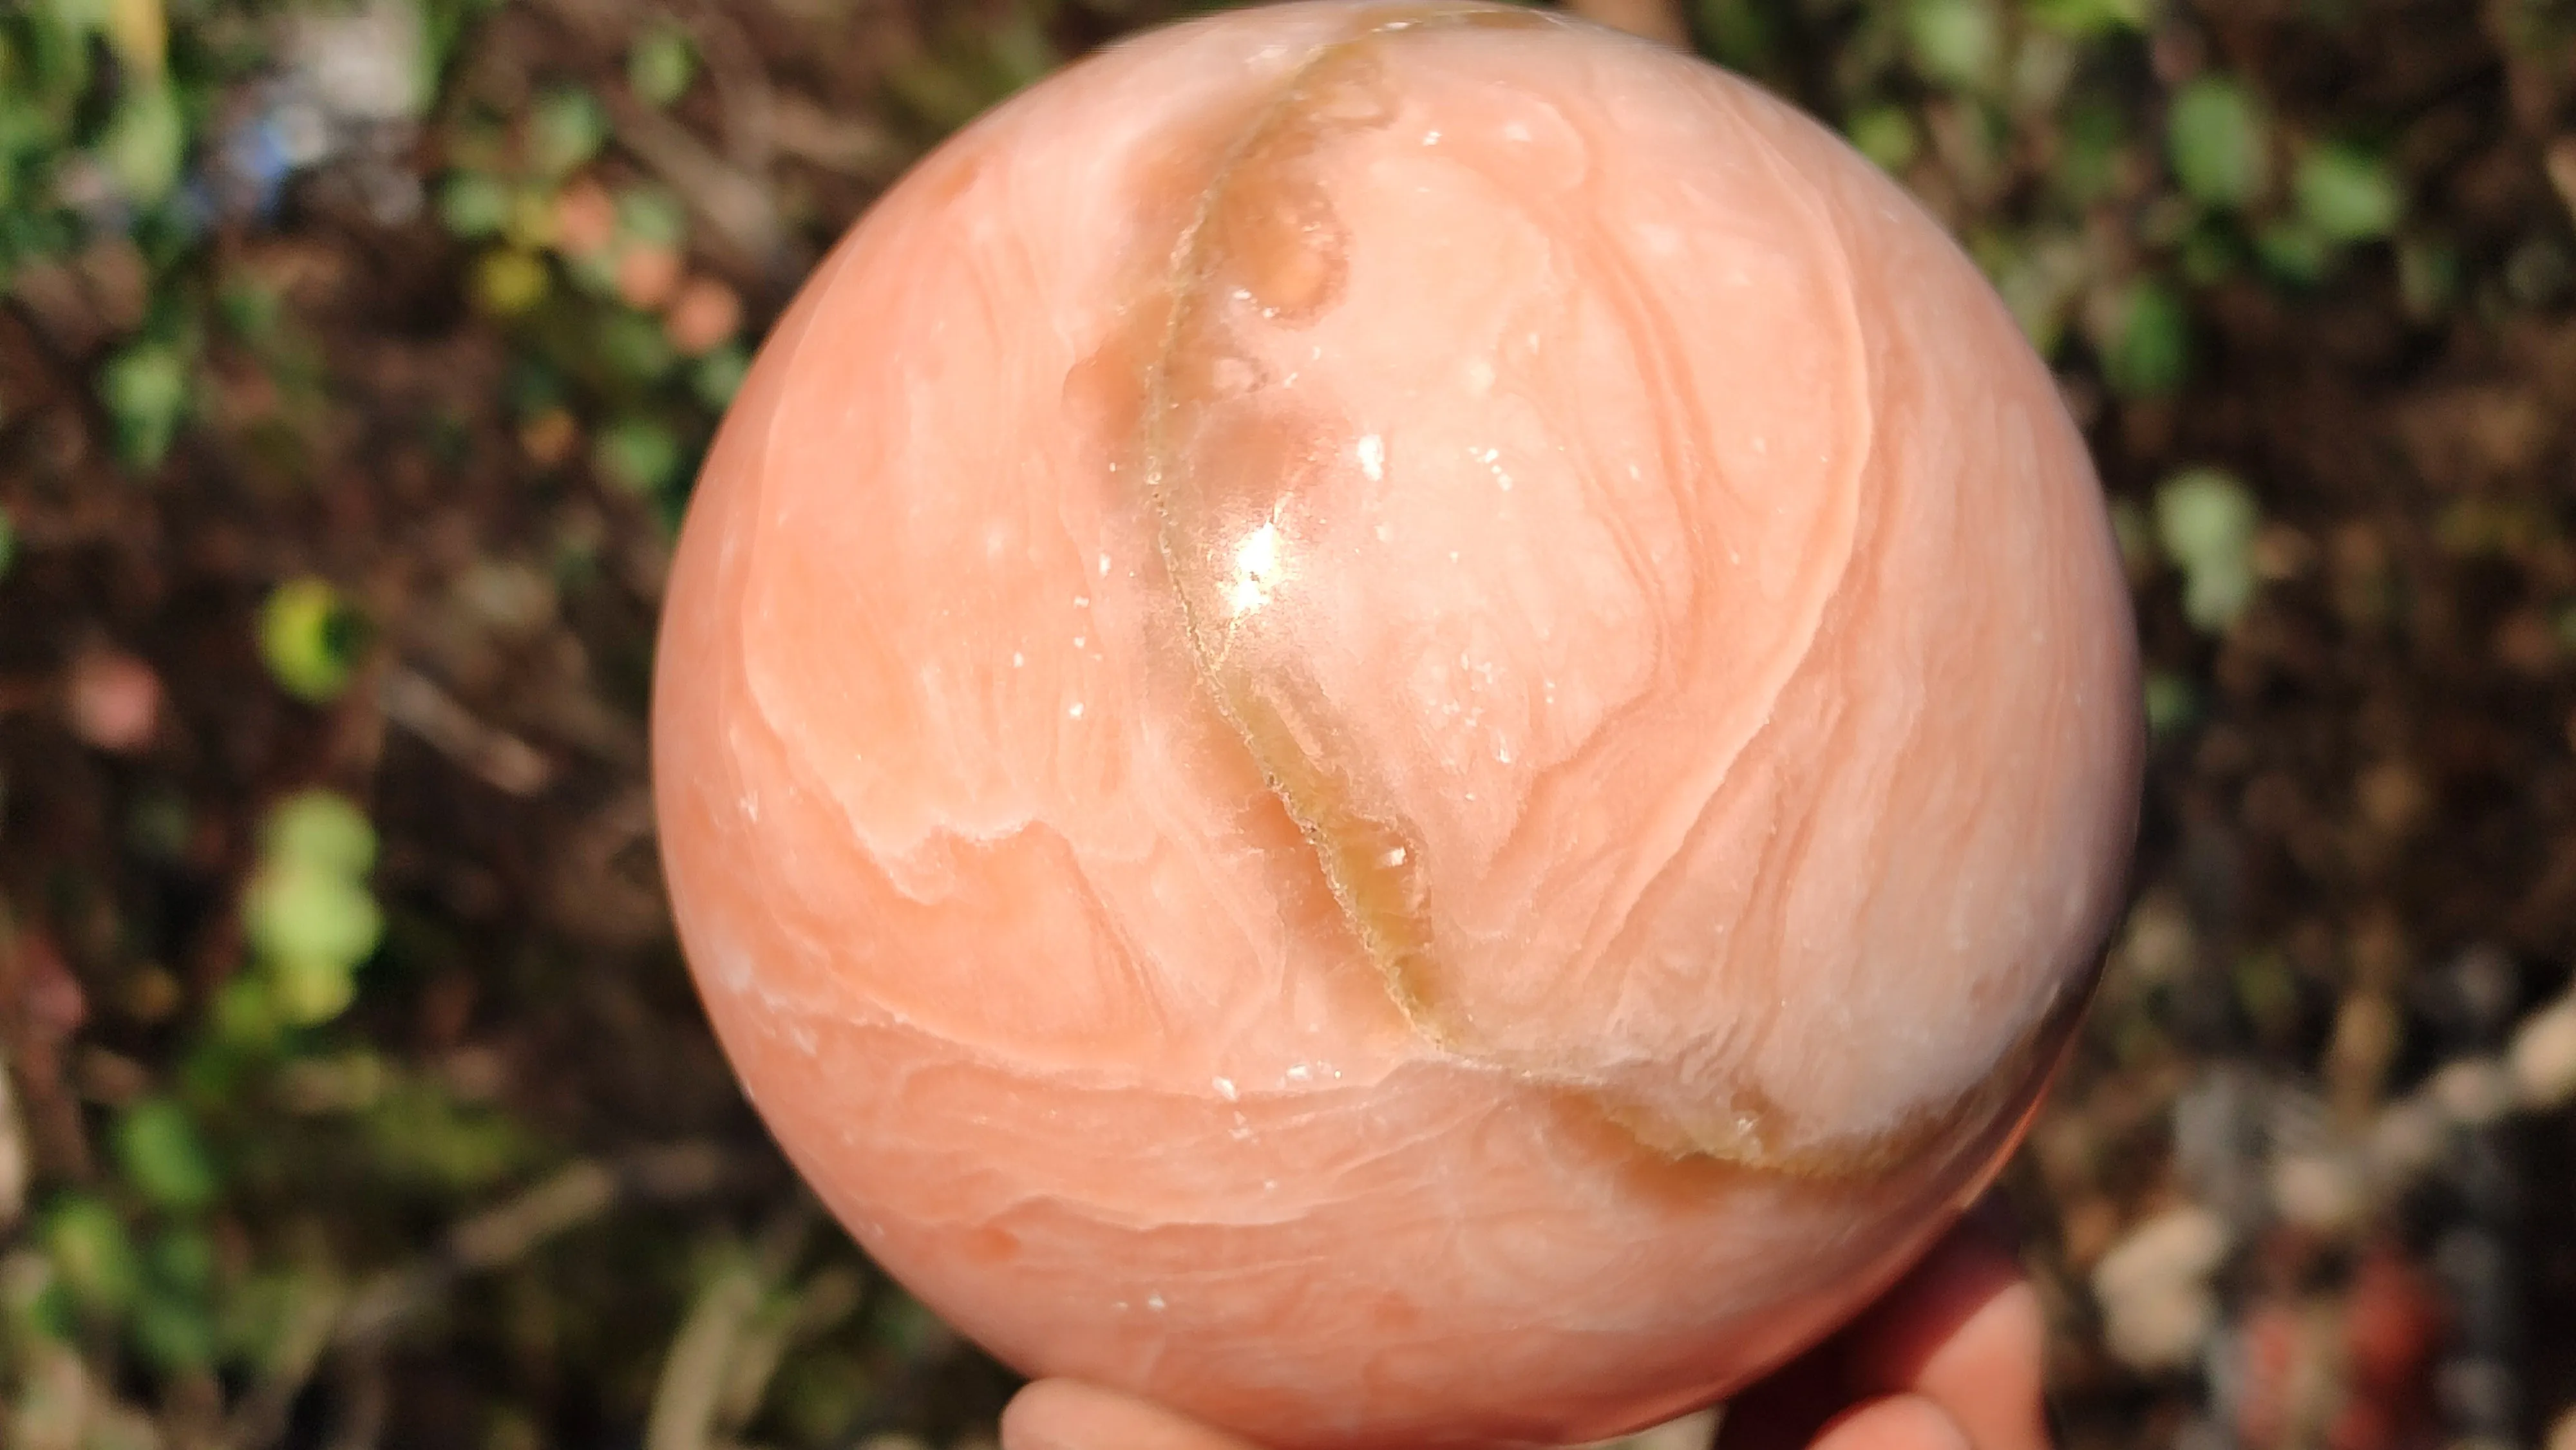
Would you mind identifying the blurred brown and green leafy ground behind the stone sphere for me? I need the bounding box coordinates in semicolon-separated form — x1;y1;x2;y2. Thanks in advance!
0;0;2576;1450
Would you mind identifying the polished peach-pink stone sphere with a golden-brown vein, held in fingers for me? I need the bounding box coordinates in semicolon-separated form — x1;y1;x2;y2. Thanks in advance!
654;3;2141;1445
